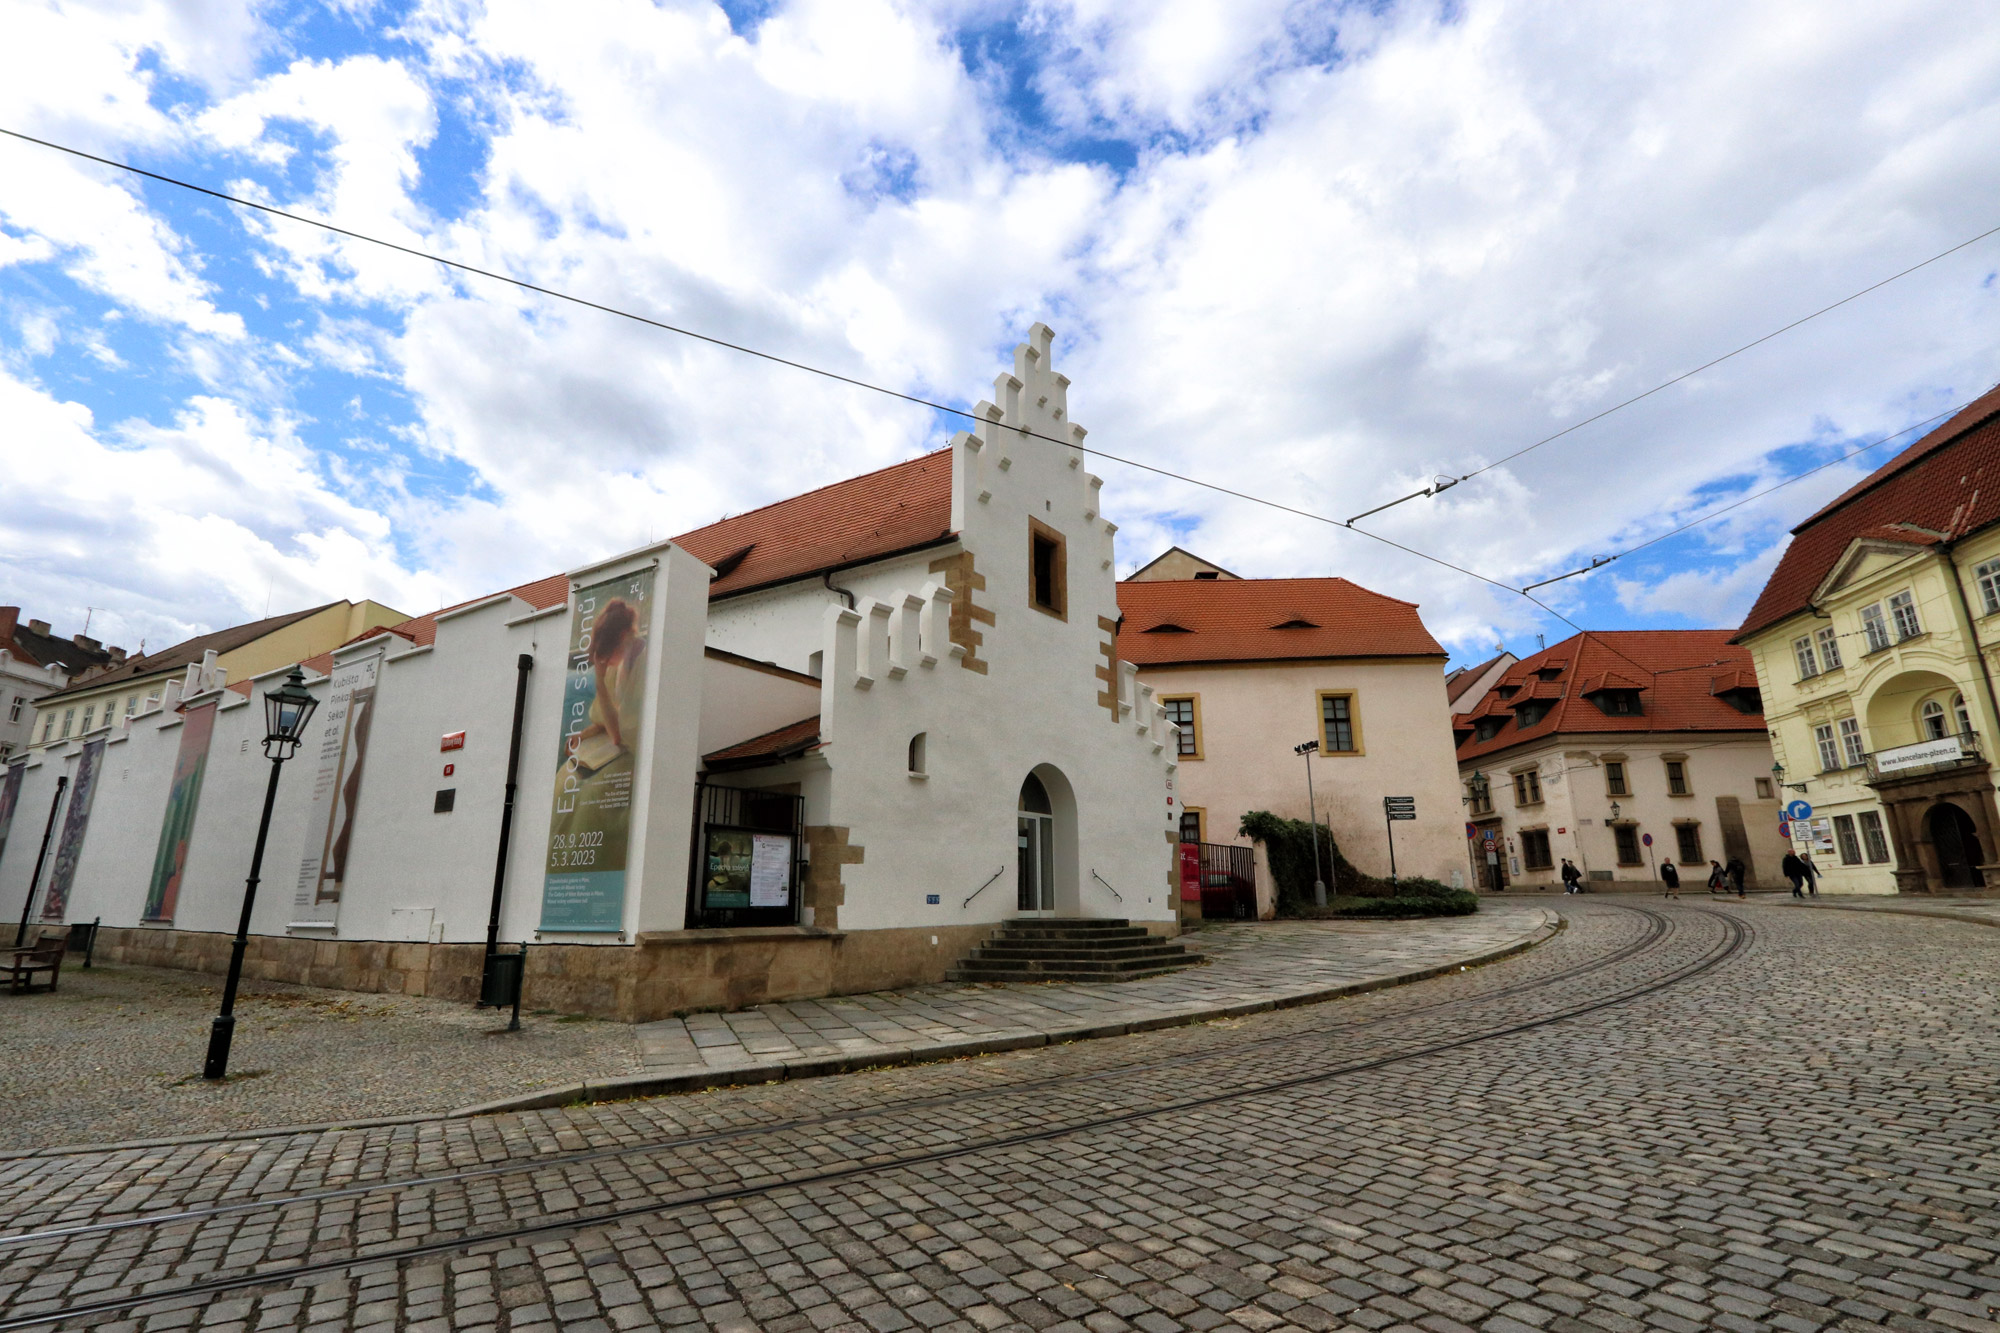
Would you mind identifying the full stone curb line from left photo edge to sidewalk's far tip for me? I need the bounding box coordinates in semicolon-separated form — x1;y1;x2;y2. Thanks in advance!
0;907;1564;1161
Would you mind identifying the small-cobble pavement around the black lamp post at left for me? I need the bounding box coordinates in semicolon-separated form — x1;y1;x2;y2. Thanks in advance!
0;961;638;1149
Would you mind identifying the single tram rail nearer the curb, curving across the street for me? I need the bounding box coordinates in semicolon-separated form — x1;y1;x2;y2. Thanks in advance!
0;903;1640;1251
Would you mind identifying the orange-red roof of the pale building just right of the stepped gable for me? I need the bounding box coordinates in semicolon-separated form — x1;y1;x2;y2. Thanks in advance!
1118;578;1444;667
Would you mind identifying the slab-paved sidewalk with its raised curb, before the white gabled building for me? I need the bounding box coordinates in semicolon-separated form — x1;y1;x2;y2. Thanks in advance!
480;901;1556;1111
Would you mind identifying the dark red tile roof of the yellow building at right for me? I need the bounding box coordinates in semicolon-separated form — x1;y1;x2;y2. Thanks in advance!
1736;384;2000;642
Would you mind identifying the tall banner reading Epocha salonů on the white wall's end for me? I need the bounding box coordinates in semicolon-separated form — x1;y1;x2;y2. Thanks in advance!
542;568;654;931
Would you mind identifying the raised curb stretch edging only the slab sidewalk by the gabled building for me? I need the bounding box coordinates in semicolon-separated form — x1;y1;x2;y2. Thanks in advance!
448;907;1562;1119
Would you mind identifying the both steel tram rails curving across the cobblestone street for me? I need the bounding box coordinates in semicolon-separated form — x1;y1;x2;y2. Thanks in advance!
0;905;1752;1333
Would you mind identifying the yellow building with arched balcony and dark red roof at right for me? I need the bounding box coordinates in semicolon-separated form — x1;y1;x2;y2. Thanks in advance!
1734;388;2000;893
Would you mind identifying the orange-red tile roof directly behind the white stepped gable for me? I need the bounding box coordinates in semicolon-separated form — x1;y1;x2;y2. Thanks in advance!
674;448;952;598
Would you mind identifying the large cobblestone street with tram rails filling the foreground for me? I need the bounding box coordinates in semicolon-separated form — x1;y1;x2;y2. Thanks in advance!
0;901;2000;1333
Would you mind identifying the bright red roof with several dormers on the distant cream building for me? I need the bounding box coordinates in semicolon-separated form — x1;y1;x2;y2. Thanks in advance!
1452;630;1764;763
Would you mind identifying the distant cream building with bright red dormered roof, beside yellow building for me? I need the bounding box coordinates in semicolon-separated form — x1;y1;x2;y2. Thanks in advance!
1452;630;1786;891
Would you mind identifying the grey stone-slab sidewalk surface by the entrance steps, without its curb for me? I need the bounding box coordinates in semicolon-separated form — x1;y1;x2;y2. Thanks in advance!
636;903;1546;1073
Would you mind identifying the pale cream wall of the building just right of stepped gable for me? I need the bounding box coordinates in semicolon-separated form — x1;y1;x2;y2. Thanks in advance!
1140;658;1466;885
